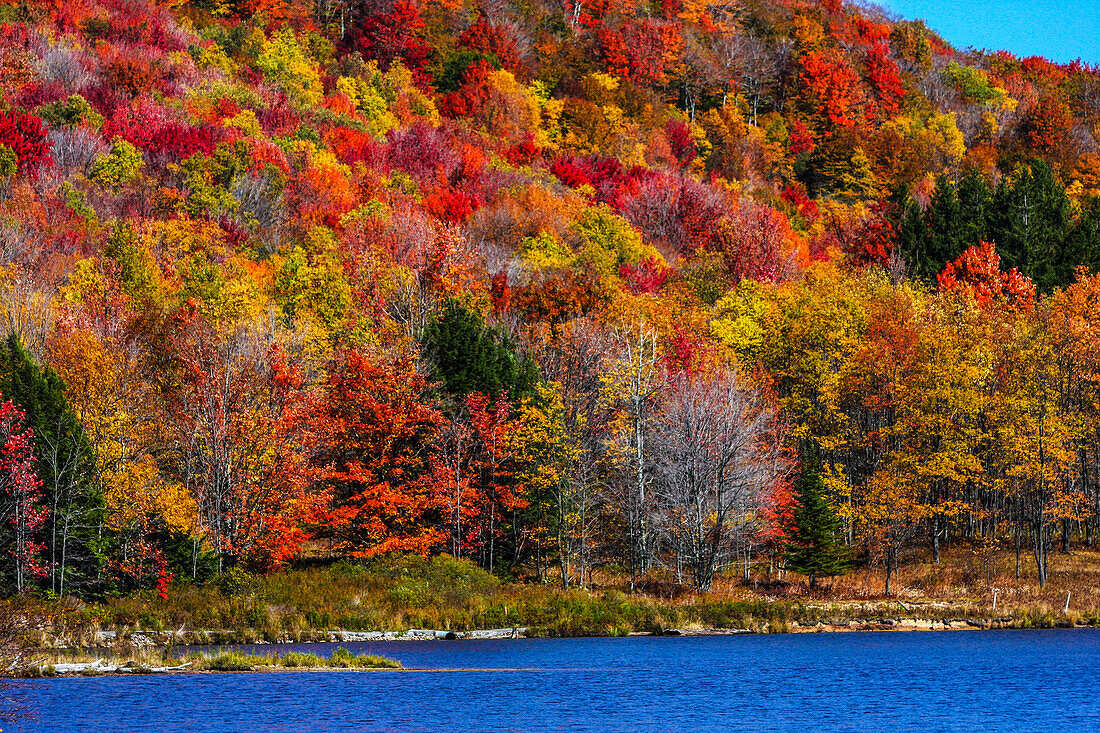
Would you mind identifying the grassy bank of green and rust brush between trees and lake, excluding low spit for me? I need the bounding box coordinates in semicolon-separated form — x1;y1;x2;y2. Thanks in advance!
23;553;1100;646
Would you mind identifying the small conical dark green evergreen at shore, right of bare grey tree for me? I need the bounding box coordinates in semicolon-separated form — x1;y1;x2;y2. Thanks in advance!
784;445;848;588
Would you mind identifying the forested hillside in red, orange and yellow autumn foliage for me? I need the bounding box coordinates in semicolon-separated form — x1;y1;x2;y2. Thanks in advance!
0;0;1100;599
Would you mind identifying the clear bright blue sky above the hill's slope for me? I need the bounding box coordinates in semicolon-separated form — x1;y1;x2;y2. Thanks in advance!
871;0;1100;64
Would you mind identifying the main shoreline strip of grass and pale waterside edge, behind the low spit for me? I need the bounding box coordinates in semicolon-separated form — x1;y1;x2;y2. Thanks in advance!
40;551;1100;654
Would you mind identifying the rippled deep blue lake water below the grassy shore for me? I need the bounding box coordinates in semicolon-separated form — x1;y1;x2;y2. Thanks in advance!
3;630;1100;733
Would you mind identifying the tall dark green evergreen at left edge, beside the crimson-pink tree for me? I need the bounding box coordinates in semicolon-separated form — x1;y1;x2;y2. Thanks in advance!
0;333;105;595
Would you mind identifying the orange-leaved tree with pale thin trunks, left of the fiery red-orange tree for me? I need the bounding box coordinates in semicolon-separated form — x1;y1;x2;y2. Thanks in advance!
159;306;322;569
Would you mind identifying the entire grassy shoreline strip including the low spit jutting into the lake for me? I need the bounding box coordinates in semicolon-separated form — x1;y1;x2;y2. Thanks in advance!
2;550;1100;677
